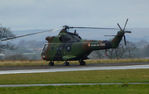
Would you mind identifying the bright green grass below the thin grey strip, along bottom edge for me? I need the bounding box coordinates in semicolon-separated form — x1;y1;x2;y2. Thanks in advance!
0;85;149;94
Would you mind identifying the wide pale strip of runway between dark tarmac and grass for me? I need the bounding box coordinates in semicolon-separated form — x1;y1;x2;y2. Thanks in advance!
0;65;149;74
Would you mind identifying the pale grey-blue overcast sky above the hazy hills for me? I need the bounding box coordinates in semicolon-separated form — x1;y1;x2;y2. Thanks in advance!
0;0;149;30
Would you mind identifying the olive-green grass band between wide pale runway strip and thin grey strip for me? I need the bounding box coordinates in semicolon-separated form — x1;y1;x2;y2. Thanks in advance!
0;69;149;84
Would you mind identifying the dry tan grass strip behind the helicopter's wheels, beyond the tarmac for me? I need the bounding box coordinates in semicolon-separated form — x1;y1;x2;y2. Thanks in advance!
0;59;149;67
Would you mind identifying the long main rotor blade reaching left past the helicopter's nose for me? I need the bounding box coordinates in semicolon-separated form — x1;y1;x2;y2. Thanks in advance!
0;29;56;41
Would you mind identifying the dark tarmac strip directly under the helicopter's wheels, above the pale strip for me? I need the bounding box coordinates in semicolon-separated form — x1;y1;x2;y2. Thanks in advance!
0;62;149;71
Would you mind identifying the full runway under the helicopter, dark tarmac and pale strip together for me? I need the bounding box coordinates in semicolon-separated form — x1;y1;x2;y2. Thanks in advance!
0;62;149;74
